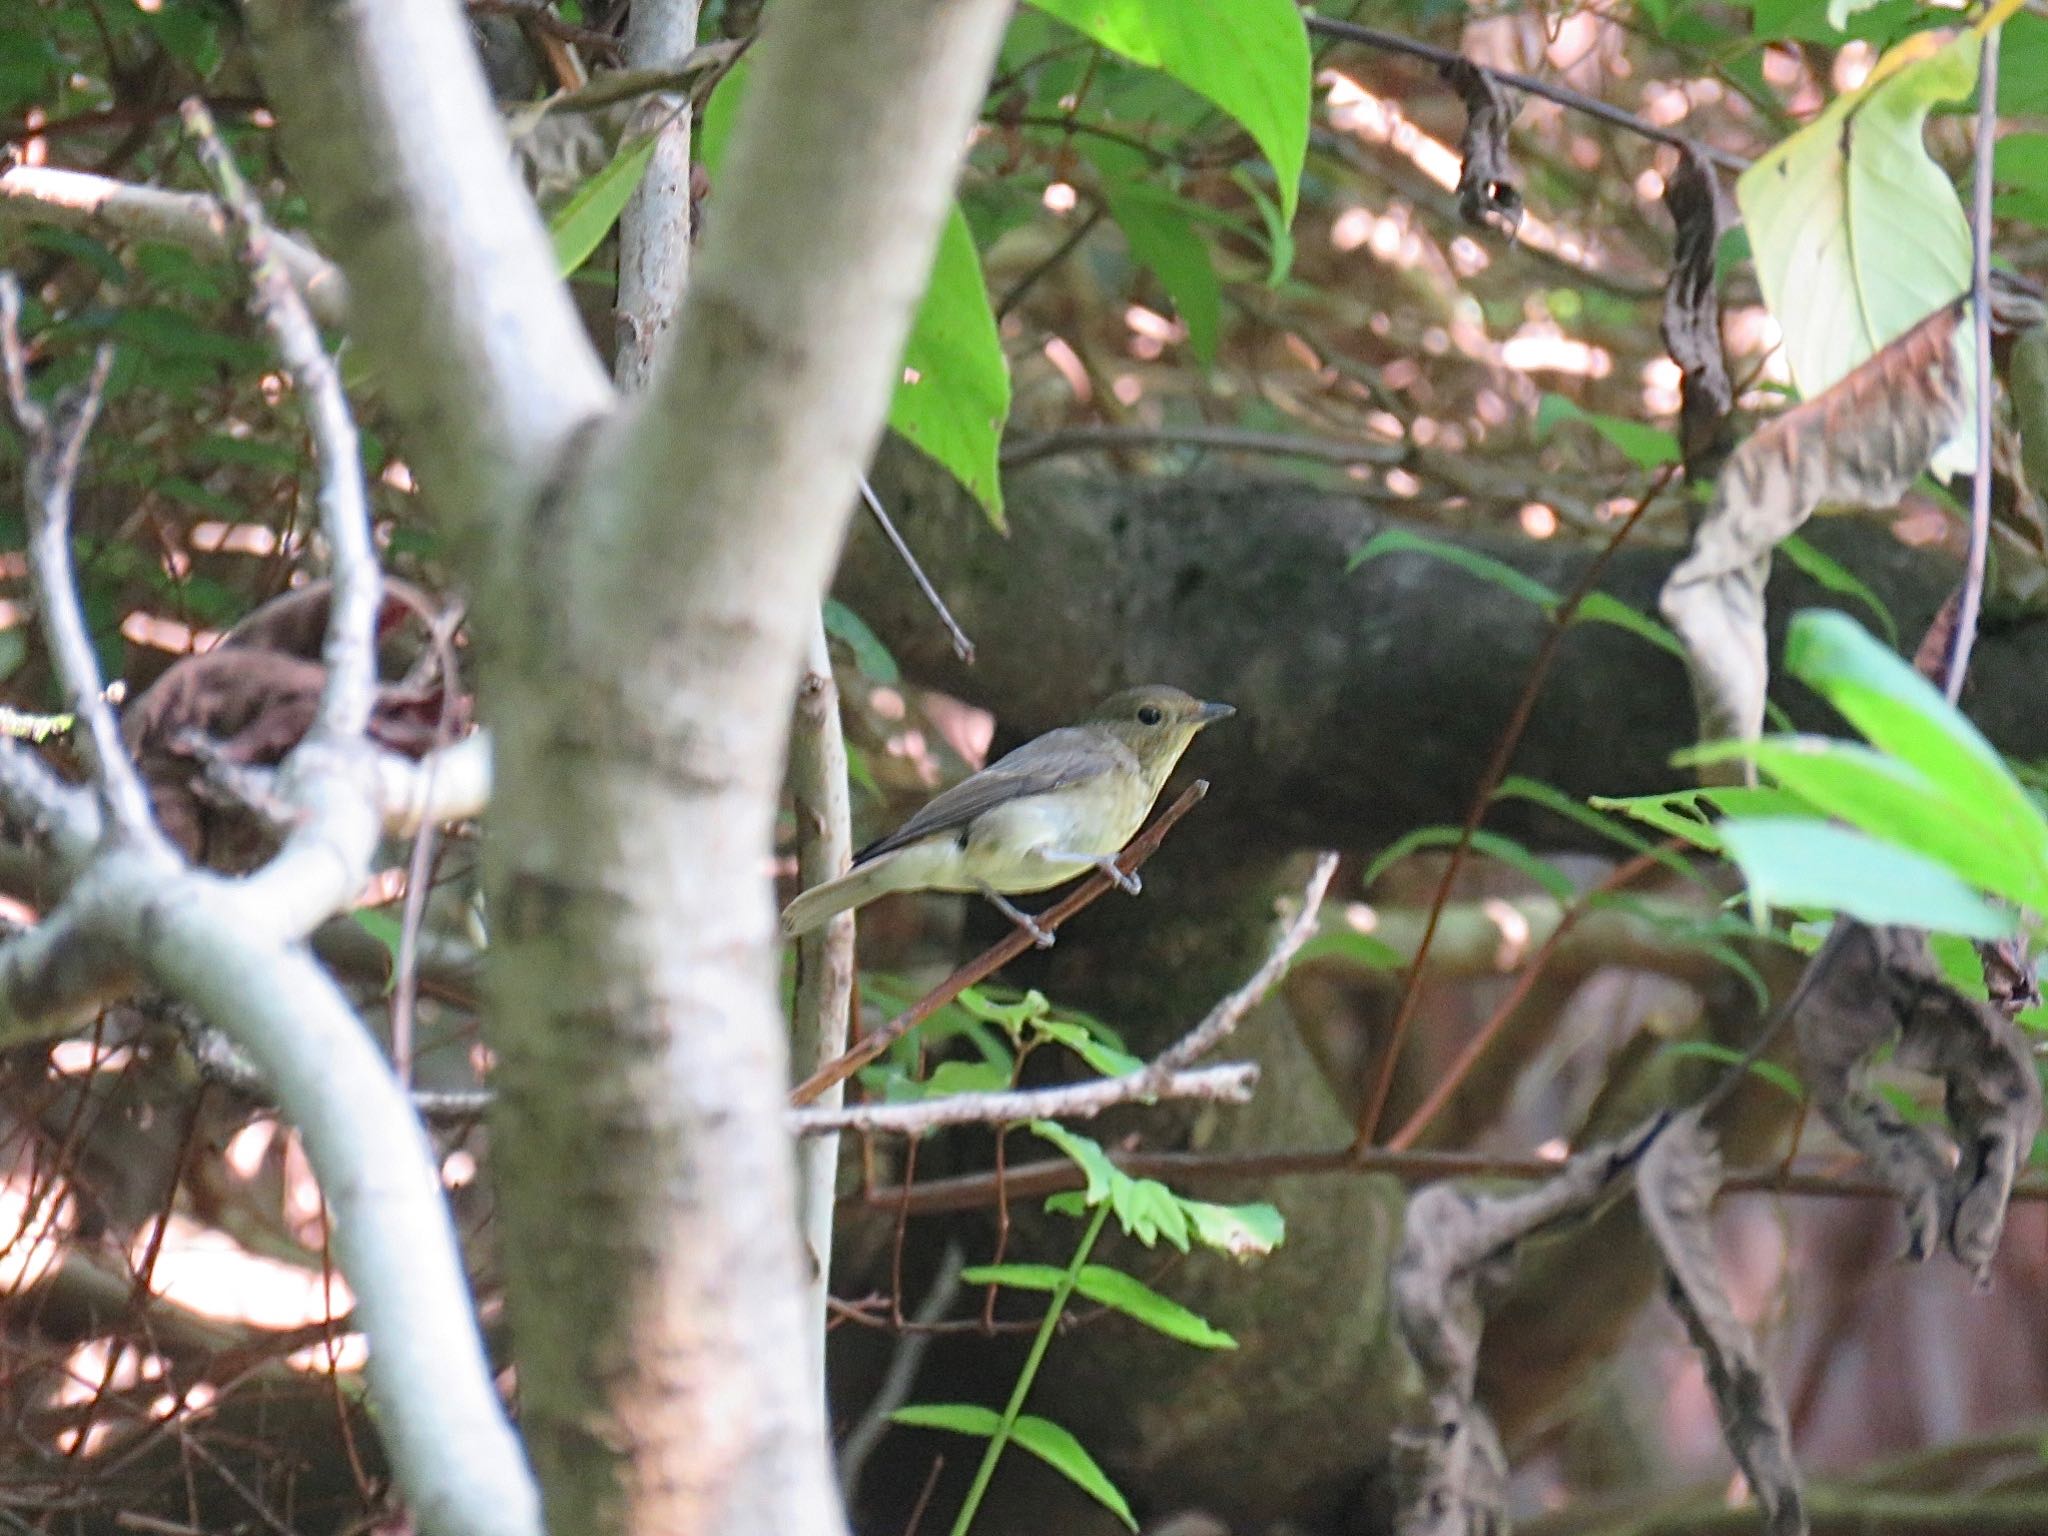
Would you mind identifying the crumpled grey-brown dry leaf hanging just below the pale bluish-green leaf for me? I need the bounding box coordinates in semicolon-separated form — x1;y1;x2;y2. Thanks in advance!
1798;920;2042;1286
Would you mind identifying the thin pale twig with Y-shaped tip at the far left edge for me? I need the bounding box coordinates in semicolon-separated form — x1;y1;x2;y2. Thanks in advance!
0;274;158;842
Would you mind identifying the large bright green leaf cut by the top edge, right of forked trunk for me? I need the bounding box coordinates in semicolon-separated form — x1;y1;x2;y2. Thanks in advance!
1032;0;1309;223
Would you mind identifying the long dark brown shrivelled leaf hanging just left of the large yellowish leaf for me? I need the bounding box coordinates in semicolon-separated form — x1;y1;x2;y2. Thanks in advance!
1663;143;1735;479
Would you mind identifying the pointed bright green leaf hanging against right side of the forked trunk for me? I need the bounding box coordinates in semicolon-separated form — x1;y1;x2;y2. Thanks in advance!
889;203;1010;528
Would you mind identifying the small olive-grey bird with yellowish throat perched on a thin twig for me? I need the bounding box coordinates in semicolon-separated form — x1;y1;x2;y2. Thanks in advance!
782;684;1237;948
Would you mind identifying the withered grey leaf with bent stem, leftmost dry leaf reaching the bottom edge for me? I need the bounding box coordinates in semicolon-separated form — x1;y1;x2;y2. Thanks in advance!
1391;1130;1647;1536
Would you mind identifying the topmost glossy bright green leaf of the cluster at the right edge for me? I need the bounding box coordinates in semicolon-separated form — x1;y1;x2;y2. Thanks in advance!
1784;610;2048;864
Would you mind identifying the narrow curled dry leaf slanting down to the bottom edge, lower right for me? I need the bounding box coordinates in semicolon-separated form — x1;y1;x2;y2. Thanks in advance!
1636;1110;1806;1536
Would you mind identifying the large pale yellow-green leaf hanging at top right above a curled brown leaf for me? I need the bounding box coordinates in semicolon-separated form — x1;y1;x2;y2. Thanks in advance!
1735;33;1978;467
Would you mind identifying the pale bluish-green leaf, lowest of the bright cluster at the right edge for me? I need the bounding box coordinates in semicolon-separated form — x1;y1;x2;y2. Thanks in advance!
1720;817;2013;938
